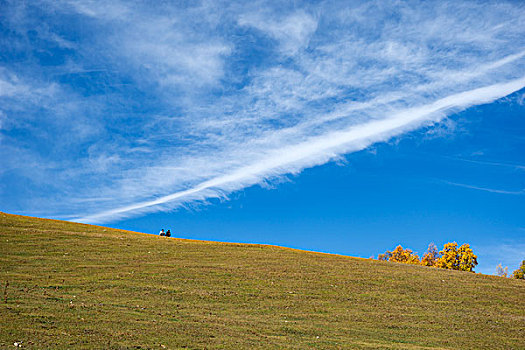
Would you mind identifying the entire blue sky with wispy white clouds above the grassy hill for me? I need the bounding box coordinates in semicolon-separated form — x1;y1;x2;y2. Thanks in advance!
0;1;525;273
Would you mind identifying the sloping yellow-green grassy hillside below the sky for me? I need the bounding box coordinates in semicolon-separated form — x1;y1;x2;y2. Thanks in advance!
0;213;525;349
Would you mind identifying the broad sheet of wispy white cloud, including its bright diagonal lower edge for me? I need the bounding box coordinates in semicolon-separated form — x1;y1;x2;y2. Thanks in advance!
0;1;525;222
